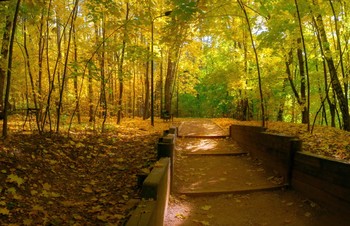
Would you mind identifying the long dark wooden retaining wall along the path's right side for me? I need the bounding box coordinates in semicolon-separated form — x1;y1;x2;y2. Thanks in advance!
230;125;350;213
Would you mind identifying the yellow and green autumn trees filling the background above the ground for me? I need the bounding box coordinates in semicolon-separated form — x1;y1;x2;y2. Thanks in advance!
0;0;350;136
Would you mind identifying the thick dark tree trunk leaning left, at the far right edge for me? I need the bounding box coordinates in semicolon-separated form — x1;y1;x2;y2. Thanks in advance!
314;3;350;131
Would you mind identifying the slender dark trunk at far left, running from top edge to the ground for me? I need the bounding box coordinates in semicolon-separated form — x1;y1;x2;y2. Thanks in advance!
2;0;21;138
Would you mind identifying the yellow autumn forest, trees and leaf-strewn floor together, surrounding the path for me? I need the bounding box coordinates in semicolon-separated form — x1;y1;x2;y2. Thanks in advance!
0;0;350;226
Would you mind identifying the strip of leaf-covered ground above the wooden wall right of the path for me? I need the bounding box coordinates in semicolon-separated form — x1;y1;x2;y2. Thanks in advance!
213;119;350;162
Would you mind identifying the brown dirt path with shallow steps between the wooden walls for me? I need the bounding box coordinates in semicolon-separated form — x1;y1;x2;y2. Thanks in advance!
165;120;349;226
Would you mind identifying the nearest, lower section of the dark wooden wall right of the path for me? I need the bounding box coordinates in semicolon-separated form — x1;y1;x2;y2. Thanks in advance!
292;152;350;213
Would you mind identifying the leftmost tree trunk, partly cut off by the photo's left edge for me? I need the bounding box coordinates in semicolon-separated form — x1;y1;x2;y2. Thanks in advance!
0;16;12;119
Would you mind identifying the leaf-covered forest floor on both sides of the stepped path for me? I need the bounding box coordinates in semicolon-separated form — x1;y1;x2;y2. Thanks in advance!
0;119;350;225
